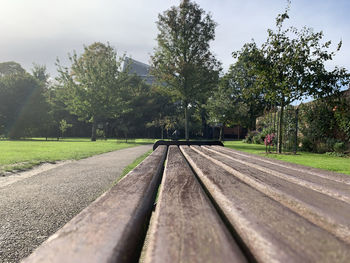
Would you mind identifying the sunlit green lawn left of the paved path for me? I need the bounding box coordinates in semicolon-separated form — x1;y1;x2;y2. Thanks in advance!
0;138;155;175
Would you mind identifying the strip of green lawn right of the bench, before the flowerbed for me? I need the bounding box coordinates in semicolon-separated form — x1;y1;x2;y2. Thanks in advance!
224;141;350;174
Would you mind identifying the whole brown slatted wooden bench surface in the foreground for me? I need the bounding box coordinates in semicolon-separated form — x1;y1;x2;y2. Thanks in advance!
23;145;350;263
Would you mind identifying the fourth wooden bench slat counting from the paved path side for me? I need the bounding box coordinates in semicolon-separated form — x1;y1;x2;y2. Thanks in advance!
195;147;350;244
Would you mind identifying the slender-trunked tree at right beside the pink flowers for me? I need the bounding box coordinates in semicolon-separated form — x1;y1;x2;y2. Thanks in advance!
245;1;349;153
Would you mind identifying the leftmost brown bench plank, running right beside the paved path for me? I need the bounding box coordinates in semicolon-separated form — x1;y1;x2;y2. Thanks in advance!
23;146;167;263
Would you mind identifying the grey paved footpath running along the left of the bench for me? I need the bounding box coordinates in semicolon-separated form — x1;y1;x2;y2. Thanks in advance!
0;145;152;263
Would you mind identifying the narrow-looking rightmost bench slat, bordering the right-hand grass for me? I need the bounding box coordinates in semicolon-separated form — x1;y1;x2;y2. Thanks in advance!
210;146;350;185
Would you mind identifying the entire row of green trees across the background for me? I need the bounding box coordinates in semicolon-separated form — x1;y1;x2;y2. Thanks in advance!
0;0;350;148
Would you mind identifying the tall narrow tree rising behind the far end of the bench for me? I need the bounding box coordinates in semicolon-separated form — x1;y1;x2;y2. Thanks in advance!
151;0;220;140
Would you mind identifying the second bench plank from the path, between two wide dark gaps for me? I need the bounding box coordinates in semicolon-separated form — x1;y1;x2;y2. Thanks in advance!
145;146;246;263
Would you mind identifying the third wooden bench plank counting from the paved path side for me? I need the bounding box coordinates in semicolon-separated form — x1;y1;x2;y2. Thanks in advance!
180;146;350;262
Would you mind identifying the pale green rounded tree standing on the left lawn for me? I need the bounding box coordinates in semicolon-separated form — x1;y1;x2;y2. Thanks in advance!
57;42;123;141
